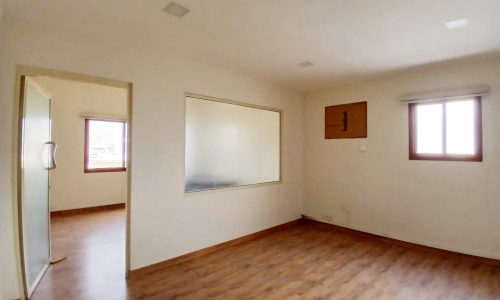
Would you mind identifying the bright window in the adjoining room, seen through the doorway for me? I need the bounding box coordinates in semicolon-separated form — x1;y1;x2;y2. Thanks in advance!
84;119;127;173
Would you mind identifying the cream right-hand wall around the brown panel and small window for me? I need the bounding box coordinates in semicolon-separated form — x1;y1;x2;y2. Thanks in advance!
304;59;500;258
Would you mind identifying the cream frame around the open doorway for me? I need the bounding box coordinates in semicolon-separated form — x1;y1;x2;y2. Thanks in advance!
13;65;133;299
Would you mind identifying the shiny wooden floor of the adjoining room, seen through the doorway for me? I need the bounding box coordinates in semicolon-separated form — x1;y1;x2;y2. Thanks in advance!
31;209;127;300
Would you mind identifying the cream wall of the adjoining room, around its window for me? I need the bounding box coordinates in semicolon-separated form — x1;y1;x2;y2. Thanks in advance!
32;77;128;211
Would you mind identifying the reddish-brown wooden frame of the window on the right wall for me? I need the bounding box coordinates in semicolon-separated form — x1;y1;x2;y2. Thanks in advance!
408;96;483;162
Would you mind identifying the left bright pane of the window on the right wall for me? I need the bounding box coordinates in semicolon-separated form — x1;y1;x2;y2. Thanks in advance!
416;104;443;154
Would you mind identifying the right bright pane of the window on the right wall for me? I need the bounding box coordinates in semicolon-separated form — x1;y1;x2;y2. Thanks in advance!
446;100;475;154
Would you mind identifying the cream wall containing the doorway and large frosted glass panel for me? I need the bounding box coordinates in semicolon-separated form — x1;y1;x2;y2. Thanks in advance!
0;15;303;298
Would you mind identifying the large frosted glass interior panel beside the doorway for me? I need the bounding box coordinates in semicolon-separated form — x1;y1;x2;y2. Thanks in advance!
185;96;281;192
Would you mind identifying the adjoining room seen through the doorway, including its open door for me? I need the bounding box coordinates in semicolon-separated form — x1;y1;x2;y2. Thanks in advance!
14;71;129;299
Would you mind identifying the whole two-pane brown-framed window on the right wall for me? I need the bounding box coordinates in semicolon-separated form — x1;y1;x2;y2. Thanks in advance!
409;97;483;161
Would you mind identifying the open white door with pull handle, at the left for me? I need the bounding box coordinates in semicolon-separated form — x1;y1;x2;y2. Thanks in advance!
19;77;55;298
